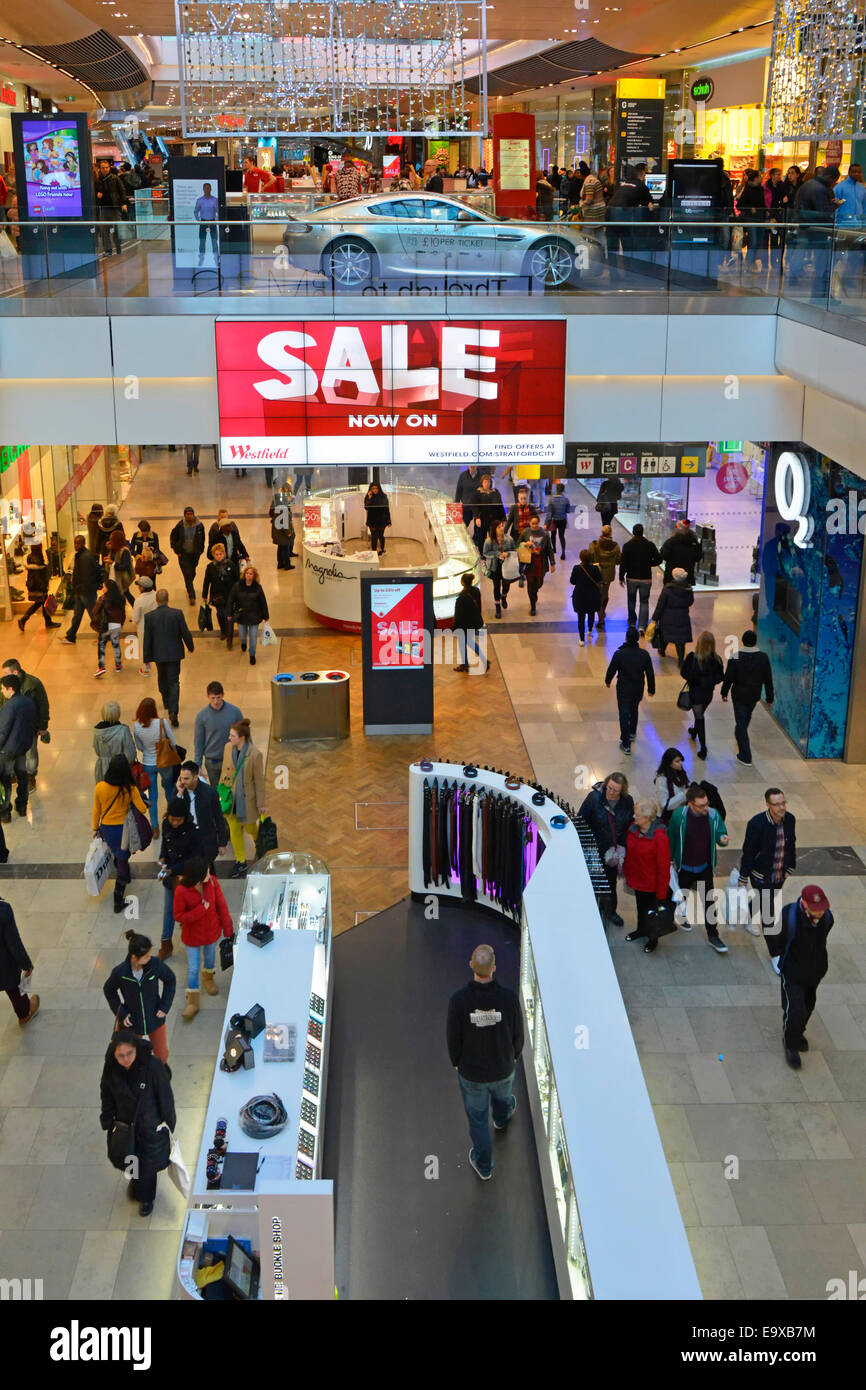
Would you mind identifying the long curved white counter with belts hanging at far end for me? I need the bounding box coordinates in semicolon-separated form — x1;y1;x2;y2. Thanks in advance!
409;762;701;1301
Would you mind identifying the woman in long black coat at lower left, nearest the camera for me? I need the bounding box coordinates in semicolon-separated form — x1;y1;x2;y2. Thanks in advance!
99;1029;177;1216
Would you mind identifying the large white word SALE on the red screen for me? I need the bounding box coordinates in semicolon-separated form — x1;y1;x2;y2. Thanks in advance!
253;324;500;406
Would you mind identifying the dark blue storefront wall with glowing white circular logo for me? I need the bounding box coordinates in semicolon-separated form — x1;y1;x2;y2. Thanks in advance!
758;443;866;758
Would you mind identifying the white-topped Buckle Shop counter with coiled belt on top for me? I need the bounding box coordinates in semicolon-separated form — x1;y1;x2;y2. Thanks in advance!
178;853;334;1301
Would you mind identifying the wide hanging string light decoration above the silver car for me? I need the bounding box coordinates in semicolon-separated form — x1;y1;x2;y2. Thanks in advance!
175;0;487;138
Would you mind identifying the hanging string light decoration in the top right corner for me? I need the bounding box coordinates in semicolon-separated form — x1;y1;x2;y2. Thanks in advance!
765;0;866;140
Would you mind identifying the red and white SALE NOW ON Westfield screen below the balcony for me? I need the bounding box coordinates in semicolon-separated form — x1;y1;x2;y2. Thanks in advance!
215;320;566;467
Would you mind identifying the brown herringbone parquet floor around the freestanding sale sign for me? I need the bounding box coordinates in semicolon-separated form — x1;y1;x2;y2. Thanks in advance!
267;632;534;934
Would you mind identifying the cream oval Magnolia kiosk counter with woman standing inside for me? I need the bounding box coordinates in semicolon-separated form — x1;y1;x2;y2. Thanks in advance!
302;484;478;632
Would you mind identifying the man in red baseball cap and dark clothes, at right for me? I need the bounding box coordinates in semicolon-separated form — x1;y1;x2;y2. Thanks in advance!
767;883;833;1070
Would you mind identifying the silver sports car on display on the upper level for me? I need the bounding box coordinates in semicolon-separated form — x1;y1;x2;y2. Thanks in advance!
282;193;603;292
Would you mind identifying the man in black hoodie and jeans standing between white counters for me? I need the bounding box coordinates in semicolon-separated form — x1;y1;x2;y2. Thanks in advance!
446;945;523;1182
